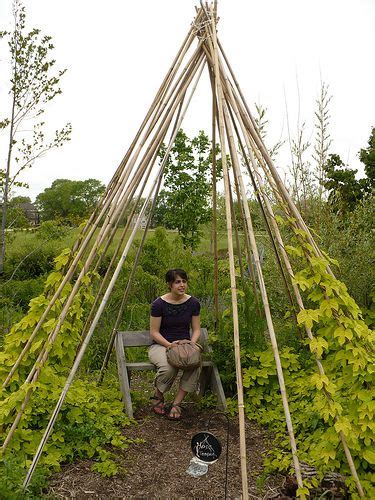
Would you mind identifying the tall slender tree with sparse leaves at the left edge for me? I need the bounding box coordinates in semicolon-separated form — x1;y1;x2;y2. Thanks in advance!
0;0;71;273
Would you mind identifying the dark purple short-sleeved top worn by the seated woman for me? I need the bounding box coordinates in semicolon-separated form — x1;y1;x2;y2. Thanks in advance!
151;297;201;342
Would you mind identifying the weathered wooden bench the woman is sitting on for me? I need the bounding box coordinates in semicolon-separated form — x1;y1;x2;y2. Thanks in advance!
115;328;226;418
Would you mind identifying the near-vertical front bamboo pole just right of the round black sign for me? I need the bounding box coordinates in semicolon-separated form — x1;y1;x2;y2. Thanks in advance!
208;6;249;500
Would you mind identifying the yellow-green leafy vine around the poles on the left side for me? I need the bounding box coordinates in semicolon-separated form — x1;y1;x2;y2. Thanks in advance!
0;250;129;487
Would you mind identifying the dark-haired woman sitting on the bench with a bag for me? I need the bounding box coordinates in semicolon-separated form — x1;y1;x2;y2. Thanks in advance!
149;269;201;420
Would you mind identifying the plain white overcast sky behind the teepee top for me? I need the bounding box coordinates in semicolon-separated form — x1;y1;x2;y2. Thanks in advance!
0;0;375;199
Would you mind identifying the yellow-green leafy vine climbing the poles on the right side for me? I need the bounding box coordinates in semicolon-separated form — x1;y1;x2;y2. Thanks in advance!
244;220;375;497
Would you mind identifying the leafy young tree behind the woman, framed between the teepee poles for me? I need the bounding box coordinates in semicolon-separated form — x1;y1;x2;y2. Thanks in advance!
154;130;217;249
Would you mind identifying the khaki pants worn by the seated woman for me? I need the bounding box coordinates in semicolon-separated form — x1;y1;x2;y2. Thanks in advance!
148;344;201;393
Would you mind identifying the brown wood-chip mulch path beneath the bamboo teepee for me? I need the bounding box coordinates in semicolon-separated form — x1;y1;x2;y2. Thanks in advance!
47;403;288;499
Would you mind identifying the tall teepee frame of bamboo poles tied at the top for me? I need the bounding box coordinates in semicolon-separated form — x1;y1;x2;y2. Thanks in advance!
2;1;363;499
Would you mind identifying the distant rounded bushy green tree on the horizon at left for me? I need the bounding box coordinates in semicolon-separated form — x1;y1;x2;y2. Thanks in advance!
35;179;105;224
